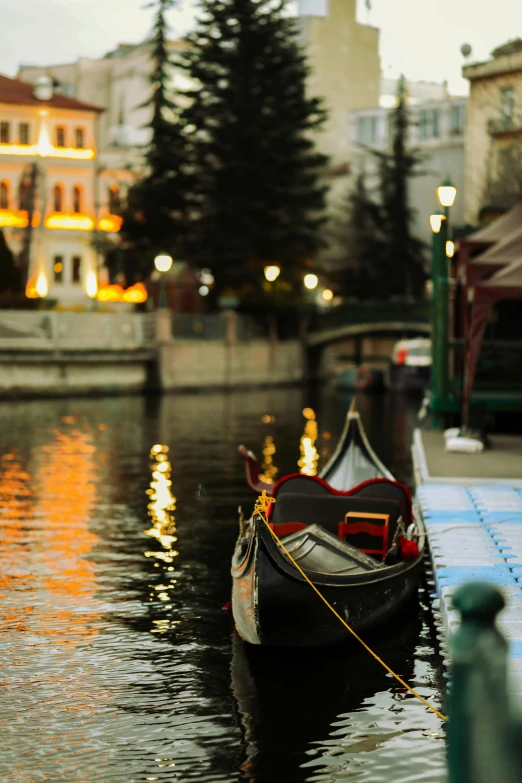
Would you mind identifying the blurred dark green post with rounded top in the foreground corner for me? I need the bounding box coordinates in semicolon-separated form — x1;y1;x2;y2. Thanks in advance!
448;583;522;783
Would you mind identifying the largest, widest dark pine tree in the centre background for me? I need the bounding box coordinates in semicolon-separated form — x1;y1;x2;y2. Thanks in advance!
177;0;327;290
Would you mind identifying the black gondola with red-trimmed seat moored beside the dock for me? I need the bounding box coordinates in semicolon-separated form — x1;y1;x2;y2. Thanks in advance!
232;404;425;647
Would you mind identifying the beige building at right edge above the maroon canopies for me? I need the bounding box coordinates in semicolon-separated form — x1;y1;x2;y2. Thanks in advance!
463;39;522;225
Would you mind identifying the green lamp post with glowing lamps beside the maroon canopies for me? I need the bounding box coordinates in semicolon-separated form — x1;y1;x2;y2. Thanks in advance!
430;180;457;428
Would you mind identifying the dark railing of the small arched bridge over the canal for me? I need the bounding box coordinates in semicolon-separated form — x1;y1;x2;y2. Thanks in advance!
309;299;431;331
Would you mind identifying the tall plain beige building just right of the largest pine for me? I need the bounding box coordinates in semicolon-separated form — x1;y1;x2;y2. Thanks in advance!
298;0;381;175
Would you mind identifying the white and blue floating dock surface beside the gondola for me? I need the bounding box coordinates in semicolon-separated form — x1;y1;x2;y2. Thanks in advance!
412;430;522;706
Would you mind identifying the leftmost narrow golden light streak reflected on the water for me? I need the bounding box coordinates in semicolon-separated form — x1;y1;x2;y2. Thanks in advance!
144;444;180;633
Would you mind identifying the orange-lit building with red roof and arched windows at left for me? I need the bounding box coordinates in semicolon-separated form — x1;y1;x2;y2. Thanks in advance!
0;76;126;305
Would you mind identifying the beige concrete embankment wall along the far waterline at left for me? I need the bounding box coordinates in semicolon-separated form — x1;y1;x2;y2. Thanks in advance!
0;311;304;398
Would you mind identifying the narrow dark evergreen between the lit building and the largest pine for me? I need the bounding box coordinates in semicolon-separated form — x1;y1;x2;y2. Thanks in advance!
117;0;189;283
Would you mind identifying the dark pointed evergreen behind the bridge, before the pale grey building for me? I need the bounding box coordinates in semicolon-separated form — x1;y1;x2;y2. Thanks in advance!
336;79;426;297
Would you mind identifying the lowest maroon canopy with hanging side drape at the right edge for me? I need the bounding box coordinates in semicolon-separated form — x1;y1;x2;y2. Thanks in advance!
463;258;522;425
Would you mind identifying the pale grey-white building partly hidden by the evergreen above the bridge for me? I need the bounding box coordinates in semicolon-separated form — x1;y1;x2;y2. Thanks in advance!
349;82;467;247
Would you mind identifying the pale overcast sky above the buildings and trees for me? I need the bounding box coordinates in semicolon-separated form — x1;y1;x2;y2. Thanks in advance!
0;0;522;93
